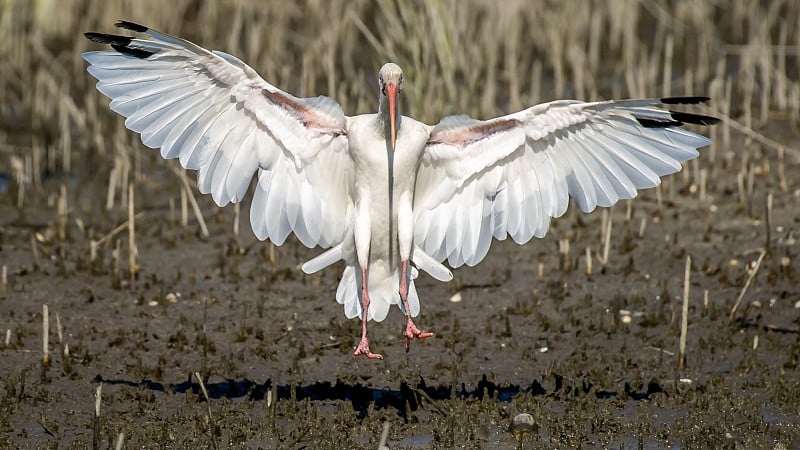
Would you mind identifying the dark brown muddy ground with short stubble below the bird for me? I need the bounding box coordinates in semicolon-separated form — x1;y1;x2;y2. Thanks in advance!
0;110;800;448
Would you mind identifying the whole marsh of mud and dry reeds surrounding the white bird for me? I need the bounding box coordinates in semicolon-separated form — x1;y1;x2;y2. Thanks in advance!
0;0;800;448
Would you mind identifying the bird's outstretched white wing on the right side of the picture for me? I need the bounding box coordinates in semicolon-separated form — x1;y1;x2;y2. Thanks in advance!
414;97;717;267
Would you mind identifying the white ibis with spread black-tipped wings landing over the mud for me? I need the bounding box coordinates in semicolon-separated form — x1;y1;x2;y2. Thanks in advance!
83;21;717;358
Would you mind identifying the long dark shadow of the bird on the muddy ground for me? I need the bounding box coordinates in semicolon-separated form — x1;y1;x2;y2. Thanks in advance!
95;374;665;420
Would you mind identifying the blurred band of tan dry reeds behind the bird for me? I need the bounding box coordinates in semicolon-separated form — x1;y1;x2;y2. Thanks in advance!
0;0;800;220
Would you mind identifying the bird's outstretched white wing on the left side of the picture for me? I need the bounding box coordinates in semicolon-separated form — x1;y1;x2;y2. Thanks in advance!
83;21;354;247
